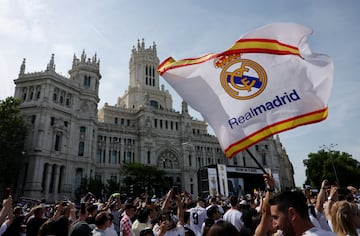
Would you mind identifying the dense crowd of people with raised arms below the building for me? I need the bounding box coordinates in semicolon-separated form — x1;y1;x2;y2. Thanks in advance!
0;174;360;236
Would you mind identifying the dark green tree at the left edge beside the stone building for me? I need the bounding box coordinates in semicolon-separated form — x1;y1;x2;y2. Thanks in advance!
0;97;26;194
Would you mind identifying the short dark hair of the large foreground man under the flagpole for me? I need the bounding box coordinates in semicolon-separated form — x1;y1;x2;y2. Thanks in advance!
269;191;309;219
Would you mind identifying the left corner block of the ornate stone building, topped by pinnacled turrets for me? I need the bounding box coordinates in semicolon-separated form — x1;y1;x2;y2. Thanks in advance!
14;52;101;201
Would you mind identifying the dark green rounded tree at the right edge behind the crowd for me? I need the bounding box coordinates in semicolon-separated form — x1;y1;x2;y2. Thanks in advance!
303;148;360;188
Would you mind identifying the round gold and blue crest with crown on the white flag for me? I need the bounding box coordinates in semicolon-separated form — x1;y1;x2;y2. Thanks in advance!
215;54;267;100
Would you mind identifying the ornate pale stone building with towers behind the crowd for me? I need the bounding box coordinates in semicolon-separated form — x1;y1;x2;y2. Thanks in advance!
14;38;294;201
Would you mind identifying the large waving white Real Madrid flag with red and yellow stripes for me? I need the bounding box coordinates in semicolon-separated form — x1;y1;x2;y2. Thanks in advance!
158;23;333;158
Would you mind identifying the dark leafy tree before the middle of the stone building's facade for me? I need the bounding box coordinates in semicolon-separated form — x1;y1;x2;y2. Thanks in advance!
124;163;165;195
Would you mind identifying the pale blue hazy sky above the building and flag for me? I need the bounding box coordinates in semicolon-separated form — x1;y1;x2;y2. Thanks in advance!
0;0;360;186
